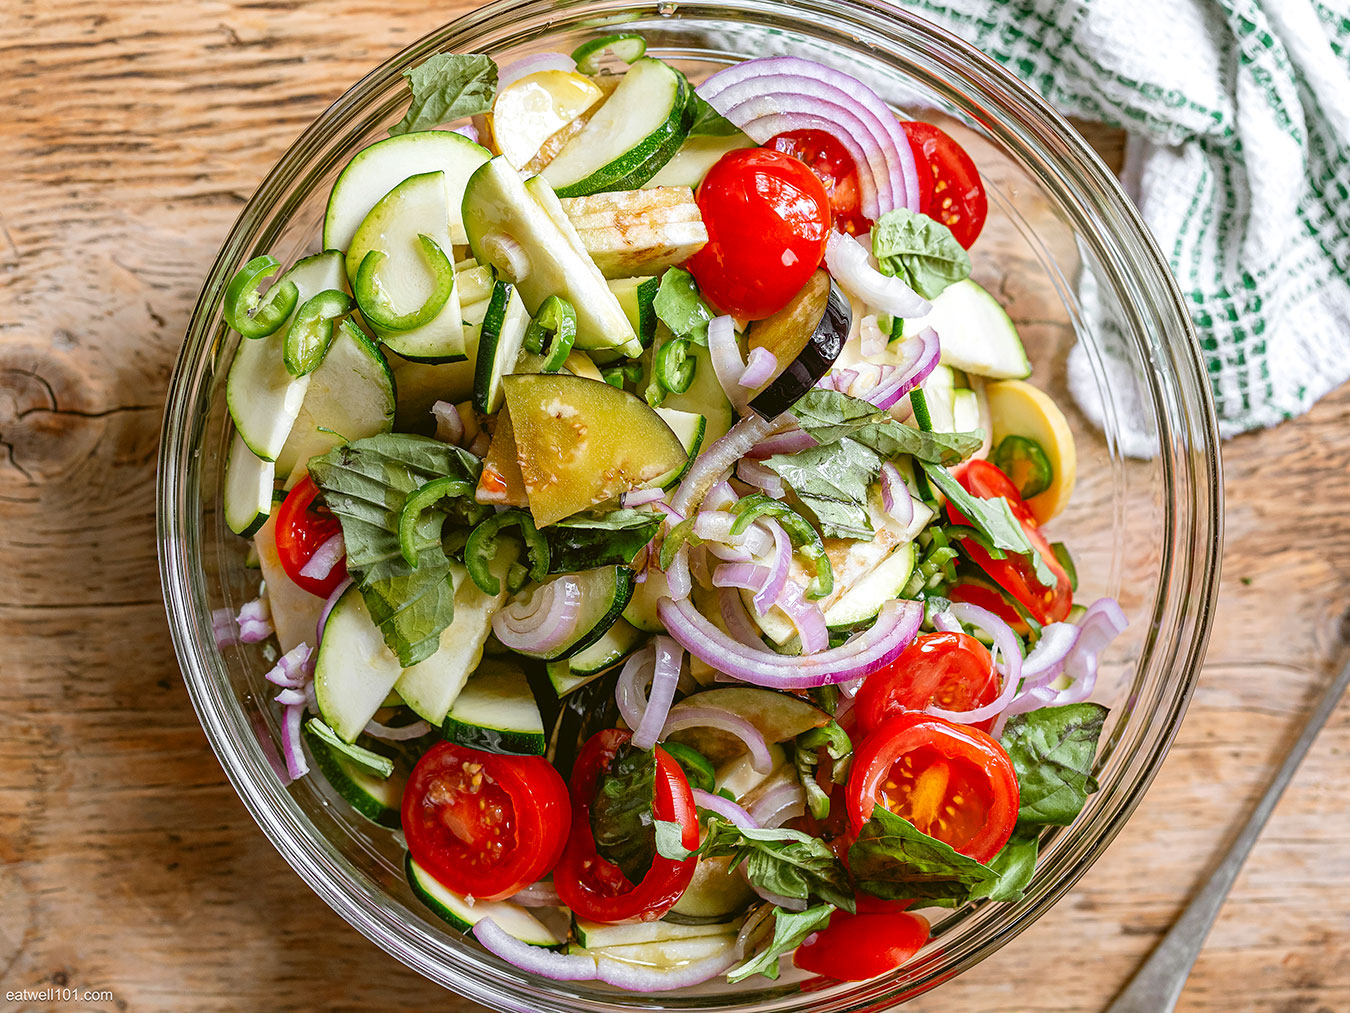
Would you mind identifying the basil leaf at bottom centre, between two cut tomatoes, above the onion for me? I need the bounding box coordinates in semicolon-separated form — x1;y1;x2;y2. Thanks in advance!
699;816;853;910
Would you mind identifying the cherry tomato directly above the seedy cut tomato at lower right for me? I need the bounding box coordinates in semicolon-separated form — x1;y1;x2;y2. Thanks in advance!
853;633;999;735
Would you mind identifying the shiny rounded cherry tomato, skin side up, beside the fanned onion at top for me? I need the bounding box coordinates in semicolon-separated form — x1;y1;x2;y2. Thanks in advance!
686;147;830;320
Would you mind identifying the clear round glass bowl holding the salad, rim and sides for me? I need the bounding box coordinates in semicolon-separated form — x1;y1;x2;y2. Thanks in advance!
158;0;1220;1013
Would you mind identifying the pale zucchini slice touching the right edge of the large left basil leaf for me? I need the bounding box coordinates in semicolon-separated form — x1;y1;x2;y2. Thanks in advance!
394;552;514;725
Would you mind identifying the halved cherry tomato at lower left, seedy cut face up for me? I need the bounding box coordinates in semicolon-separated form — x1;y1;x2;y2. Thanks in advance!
402;742;571;901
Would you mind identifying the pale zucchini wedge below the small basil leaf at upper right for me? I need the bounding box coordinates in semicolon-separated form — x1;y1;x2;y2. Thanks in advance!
903;278;1031;380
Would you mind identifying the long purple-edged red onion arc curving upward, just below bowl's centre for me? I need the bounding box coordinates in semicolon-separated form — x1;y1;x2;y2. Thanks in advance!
656;598;923;689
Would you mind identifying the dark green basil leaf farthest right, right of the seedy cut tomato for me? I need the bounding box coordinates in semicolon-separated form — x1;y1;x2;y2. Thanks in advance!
1002;704;1108;827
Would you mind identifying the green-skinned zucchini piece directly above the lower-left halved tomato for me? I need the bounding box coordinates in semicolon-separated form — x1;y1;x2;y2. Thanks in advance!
441;660;547;756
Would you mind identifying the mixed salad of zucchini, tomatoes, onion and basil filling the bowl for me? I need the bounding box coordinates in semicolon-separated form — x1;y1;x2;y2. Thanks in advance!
216;34;1126;993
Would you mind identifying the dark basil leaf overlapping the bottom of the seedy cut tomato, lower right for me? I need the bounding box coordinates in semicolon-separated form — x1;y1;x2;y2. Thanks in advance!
848;806;999;901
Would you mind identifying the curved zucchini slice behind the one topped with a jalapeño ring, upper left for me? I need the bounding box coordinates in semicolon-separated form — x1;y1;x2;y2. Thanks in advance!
324;130;491;255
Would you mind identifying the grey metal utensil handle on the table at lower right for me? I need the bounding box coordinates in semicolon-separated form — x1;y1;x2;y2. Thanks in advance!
1106;660;1350;1013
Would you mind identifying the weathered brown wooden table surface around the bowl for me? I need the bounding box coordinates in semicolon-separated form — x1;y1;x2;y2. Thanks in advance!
0;0;1350;1013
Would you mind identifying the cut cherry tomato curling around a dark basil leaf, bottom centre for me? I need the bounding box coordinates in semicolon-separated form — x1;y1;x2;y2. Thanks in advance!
554;728;698;923
